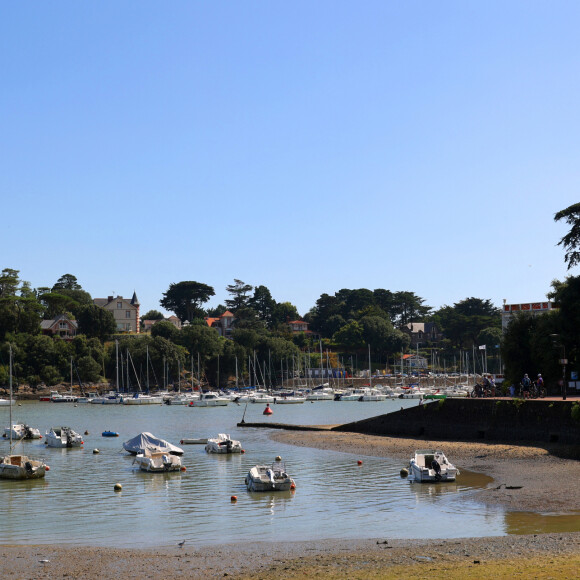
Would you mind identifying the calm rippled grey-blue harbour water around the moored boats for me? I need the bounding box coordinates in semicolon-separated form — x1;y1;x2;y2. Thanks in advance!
0;400;572;547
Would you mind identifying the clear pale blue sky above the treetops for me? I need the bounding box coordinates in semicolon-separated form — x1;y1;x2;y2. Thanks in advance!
0;0;580;315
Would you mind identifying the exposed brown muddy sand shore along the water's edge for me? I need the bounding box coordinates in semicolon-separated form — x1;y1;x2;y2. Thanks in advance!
0;431;580;579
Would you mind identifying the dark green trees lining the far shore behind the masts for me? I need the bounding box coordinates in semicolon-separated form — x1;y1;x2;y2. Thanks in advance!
0;204;580;387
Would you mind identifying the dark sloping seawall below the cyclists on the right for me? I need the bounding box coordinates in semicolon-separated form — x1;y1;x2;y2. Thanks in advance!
333;399;580;445
